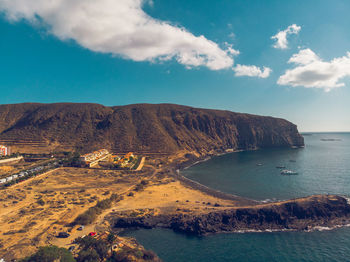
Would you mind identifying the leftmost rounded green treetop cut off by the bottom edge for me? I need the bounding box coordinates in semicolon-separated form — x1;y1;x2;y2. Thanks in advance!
21;246;76;262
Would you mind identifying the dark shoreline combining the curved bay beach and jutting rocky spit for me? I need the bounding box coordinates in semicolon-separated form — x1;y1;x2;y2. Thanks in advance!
111;150;350;235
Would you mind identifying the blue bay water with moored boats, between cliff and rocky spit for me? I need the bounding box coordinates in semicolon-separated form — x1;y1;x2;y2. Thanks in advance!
183;134;350;200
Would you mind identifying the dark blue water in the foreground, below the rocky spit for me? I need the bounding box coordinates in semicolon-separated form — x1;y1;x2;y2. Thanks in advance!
124;228;350;262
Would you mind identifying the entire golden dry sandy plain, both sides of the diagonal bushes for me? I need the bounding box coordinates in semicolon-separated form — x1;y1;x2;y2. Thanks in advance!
0;160;241;258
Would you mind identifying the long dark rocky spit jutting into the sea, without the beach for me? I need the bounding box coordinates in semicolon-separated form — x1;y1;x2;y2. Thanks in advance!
114;195;350;235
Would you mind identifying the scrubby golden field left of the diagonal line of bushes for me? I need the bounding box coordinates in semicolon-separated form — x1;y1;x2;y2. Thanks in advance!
0;168;139;257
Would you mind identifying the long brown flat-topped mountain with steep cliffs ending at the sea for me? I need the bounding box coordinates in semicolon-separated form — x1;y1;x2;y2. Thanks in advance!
0;103;304;154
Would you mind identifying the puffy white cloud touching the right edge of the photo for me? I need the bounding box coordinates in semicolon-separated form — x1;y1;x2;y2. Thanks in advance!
277;49;350;92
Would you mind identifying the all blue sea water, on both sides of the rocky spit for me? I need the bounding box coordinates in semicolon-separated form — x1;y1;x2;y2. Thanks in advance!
125;133;350;262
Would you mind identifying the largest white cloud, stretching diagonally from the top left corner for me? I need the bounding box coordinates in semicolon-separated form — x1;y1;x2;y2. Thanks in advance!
0;0;237;70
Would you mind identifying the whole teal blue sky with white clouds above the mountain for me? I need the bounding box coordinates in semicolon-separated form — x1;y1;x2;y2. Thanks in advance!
0;0;350;132
